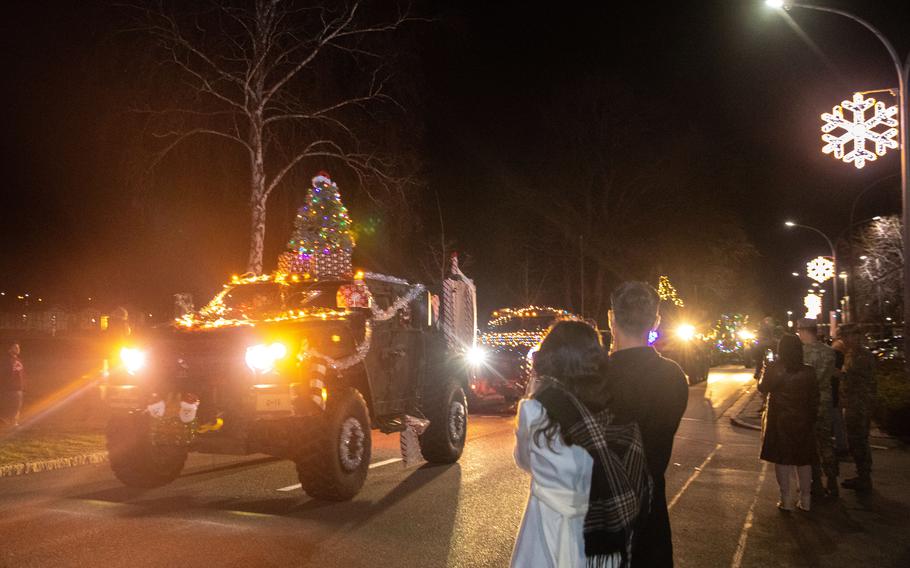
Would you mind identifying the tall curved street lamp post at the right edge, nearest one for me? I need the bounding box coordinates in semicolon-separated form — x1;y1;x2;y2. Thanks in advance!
766;0;910;364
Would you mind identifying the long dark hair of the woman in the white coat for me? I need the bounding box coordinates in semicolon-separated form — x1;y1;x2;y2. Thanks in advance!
533;320;607;448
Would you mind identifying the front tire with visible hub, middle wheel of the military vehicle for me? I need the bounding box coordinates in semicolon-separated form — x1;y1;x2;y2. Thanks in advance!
296;389;372;501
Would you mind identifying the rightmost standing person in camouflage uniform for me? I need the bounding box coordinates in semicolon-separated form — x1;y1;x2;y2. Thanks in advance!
839;325;875;491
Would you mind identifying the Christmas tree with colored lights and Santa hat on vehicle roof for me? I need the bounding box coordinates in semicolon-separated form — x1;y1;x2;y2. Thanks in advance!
278;172;354;279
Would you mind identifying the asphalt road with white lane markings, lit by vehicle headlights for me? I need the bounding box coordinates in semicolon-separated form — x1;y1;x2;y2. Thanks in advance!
0;369;910;568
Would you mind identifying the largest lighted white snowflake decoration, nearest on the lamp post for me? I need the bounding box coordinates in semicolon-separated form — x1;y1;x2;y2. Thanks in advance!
822;93;897;169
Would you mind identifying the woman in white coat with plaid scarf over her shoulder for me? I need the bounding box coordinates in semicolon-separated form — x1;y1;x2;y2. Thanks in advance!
511;321;652;568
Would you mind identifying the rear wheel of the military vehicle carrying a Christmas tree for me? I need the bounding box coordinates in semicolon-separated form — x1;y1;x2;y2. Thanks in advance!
420;380;468;463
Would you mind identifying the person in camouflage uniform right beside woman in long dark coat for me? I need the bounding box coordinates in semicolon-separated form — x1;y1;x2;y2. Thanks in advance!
797;318;839;497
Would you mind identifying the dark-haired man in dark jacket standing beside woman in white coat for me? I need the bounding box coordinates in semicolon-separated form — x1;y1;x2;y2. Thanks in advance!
607;282;689;567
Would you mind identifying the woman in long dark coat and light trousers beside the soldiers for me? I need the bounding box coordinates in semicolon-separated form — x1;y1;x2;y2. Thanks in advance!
758;335;819;511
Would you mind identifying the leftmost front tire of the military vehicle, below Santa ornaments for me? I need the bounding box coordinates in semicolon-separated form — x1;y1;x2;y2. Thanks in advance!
107;413;188;489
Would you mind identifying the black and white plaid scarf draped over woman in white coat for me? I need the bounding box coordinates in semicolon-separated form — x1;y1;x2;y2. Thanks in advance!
534;377;654;567
